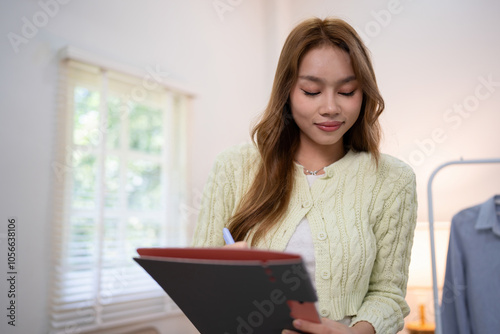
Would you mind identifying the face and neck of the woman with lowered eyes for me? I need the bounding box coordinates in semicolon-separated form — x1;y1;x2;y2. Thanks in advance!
290;46;363;152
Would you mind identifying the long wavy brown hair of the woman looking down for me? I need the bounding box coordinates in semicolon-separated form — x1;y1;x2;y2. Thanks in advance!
229;18;384;245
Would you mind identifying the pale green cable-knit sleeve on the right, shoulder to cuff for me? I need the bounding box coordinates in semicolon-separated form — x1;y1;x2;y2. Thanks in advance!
351;166;417;334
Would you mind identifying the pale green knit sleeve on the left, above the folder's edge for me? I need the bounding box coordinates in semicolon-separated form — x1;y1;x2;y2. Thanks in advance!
191;155;235;247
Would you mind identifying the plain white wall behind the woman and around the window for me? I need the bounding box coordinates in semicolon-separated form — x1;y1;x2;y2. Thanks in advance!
0;0;500;333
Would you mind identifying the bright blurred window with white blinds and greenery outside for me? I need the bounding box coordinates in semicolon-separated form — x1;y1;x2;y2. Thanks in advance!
50;50;191;333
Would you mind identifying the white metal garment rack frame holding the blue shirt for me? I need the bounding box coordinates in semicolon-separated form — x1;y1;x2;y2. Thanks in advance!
427;158;500;334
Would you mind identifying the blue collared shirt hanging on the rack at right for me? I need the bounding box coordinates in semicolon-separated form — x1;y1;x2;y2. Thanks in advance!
441;195;500;334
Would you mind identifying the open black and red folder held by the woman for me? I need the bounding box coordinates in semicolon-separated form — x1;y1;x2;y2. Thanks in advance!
134;248;320;334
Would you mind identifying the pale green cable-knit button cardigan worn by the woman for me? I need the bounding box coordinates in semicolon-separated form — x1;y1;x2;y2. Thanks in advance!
193;144;417;334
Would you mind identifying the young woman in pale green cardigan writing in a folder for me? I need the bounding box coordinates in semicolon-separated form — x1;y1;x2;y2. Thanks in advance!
194;18;417;334
